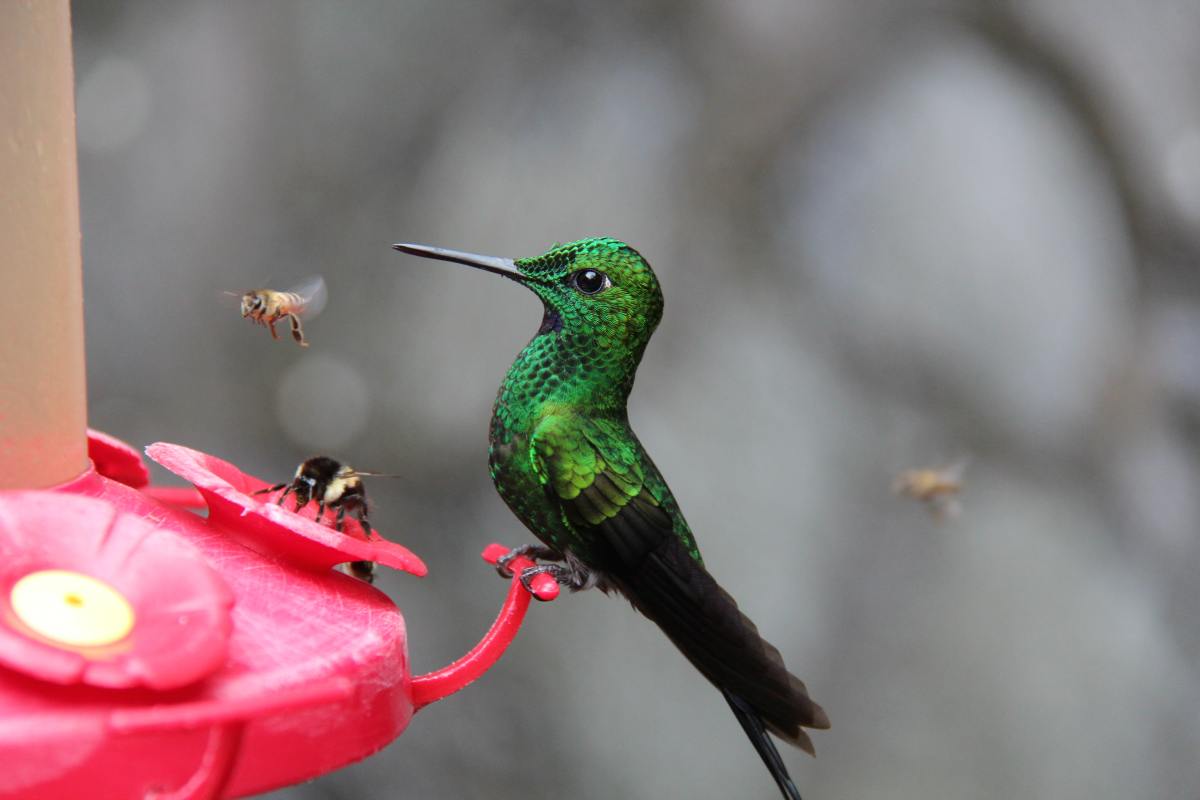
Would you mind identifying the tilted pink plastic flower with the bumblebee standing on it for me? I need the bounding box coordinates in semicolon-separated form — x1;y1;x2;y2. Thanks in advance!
146;441;428;577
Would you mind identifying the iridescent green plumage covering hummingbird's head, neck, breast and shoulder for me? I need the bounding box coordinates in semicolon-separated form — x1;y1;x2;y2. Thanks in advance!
488;239;700;569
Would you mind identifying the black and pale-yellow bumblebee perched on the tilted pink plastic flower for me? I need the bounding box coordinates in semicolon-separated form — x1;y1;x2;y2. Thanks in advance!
254;456;397;583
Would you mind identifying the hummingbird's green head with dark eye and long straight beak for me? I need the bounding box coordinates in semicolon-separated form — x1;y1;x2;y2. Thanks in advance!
394;237;662;355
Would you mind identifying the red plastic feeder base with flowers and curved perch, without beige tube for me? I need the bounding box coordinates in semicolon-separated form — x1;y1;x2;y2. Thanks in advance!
0;432;558;800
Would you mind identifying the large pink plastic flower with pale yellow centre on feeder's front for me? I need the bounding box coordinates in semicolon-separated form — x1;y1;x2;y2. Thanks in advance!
0;492;233;690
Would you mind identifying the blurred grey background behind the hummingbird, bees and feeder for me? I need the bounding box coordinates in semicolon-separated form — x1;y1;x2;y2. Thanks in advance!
74;0;1200;800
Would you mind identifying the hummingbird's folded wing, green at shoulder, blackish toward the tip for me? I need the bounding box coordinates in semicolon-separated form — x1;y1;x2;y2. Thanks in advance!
530;416;829;758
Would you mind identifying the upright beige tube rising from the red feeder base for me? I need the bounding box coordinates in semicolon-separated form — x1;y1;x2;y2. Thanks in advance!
0;0;88;488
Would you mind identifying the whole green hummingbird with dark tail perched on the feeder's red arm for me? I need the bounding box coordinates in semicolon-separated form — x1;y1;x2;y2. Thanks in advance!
392;237;829;800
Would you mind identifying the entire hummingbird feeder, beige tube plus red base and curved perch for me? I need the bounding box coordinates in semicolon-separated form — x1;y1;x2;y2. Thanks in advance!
0;2;558;800
